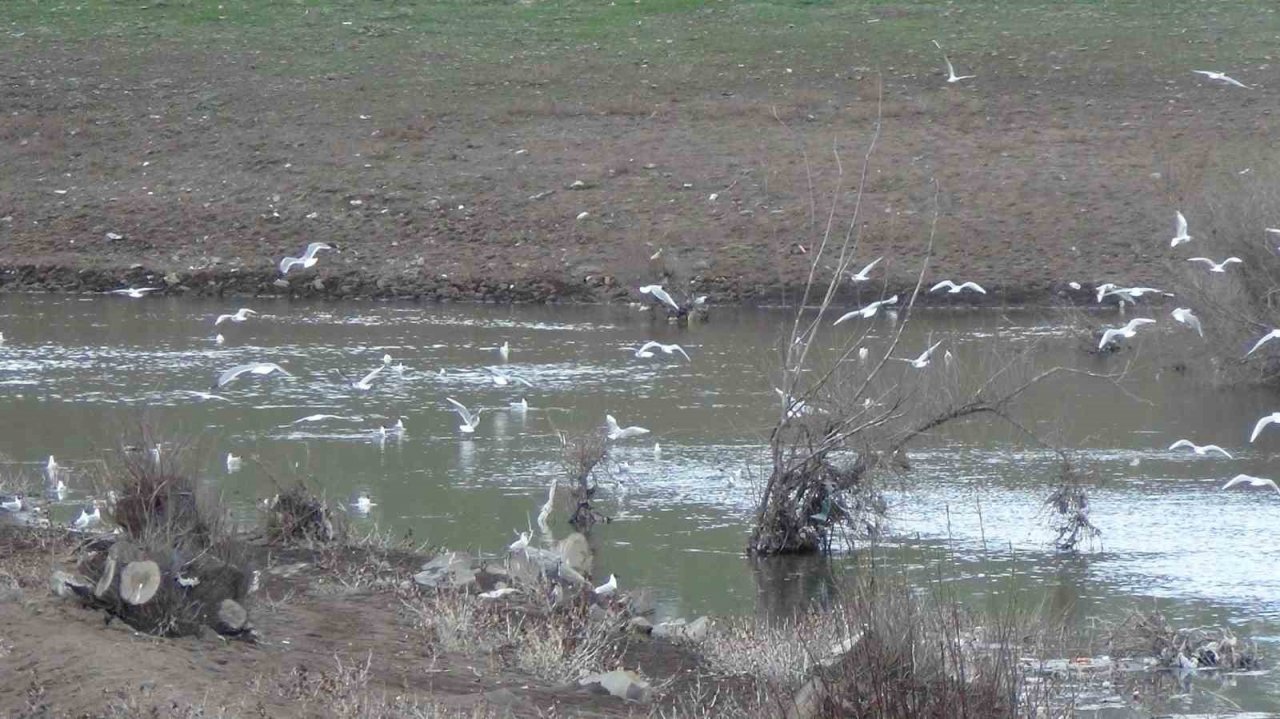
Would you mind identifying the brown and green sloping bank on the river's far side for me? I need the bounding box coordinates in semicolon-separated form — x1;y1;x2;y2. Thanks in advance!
0;0;1276;303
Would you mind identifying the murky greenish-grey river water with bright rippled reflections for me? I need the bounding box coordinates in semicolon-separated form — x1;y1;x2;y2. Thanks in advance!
0;296;1280;713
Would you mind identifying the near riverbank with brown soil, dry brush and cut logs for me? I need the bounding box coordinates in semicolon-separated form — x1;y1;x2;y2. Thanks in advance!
0;450;1258;719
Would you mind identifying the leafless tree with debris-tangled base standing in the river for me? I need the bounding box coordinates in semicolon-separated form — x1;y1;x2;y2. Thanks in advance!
748;110;1098;557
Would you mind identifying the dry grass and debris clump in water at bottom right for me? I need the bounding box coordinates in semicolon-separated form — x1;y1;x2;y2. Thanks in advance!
1110;612;1258;669
